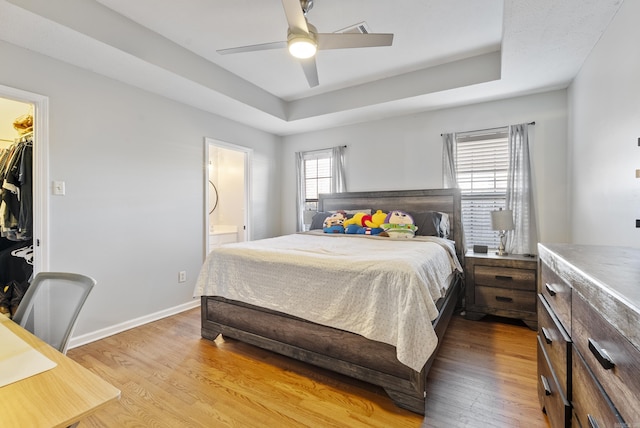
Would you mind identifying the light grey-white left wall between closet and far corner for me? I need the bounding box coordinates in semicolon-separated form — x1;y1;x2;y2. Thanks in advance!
0;42;280;336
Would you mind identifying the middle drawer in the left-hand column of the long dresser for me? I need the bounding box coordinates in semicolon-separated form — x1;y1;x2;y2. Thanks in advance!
538;294;571;400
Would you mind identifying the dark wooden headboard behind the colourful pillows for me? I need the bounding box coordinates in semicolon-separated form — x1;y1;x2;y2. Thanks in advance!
318;189;465;265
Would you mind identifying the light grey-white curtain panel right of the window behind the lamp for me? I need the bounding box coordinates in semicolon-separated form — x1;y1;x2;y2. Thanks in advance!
505;123;538;254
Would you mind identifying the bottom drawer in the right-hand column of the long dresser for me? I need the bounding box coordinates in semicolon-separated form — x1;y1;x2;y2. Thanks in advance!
572;349;625;428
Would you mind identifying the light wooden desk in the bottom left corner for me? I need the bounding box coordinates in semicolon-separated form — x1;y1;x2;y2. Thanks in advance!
0;316;120;428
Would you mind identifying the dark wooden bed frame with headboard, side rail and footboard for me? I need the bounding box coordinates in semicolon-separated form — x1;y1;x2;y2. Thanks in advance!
201;189;464;414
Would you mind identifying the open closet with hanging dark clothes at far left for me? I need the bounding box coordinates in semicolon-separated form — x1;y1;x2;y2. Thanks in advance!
0;105;34;316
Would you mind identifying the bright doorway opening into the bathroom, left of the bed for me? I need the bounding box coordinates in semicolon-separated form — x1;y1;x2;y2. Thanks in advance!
205;138;252;254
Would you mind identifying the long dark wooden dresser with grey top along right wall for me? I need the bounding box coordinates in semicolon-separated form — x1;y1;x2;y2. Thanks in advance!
537;244;640;428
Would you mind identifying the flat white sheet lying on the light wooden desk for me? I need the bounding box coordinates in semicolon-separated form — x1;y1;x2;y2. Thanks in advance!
0;324;56;387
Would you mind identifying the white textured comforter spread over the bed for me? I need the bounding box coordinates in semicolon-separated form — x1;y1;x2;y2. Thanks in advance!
194;232;462;371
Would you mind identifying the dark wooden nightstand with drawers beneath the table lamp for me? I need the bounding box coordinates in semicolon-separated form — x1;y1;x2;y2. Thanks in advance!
465;251;538;330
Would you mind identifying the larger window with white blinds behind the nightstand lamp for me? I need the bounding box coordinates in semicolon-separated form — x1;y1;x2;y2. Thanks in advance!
455;128;509;248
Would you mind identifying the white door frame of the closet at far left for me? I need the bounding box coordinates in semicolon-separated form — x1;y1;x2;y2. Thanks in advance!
0;85;50;275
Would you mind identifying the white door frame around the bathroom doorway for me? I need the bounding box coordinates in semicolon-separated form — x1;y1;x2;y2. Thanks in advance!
203;137;253;258
